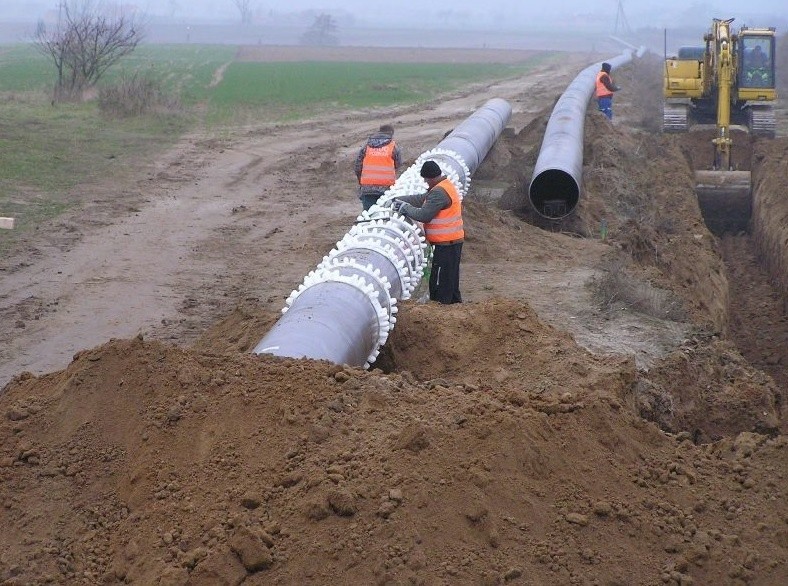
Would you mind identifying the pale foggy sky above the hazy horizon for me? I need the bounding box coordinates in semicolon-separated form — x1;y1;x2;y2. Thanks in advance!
0;0;788;30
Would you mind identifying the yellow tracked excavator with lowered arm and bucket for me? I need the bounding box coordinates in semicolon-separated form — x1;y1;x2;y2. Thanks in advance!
662;18;777;232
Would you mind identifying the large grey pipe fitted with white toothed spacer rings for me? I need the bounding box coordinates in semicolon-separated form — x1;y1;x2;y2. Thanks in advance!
253;98;512;368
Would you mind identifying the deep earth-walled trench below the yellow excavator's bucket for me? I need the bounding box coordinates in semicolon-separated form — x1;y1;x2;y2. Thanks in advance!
680;130;788;389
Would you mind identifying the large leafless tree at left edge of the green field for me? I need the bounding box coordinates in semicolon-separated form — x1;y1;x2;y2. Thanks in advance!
34;0;142;102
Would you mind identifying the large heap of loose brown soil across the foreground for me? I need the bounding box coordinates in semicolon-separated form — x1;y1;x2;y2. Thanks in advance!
0;300;788;585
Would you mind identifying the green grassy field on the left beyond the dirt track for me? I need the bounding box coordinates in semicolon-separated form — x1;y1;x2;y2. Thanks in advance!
0;45;558;251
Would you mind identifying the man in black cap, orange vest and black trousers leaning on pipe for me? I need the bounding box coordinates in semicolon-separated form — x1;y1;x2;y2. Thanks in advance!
392;161;465;304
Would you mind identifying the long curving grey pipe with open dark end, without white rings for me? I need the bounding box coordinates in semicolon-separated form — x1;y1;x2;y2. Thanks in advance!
528;50;632;219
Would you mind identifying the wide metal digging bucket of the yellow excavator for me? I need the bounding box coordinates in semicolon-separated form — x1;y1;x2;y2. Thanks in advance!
695;171;752;236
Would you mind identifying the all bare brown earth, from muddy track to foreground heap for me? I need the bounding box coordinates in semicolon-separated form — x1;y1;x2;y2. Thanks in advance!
0;48;788;585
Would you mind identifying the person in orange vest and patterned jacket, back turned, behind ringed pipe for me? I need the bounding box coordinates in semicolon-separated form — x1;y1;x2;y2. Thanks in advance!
354;124;402;210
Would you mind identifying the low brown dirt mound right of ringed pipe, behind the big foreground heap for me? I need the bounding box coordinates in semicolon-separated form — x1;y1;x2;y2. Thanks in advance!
385;299;635;401
